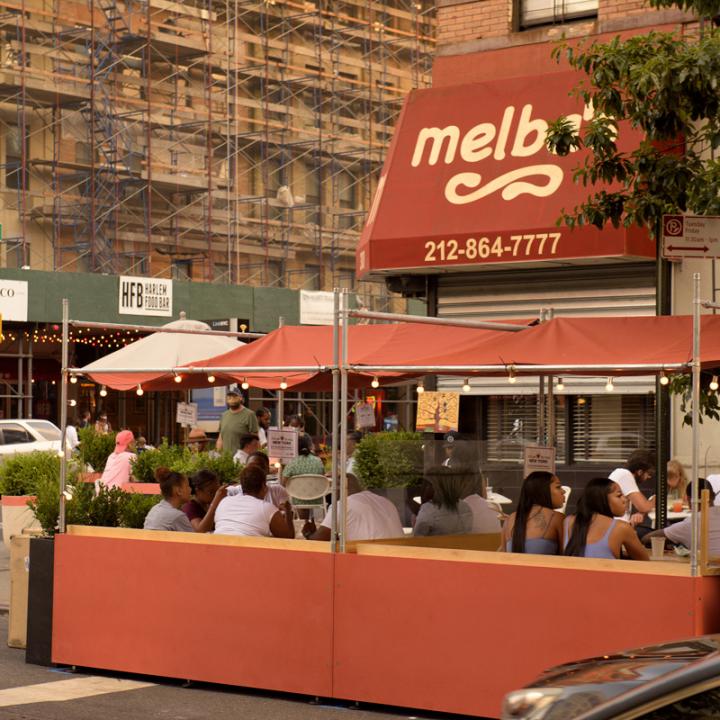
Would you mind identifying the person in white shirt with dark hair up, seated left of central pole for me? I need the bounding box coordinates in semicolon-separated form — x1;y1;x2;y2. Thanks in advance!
215;464;295;538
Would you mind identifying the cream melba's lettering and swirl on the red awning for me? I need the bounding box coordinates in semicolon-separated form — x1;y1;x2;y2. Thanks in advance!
410;104;592;205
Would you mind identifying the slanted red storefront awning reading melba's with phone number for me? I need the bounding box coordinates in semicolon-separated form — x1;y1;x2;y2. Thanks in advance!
357;72;655;277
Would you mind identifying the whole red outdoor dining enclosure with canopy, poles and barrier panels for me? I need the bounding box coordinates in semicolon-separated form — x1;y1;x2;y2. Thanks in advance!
46;276;720;717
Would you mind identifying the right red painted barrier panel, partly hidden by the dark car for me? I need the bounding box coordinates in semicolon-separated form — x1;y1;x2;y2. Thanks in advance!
334;555;720;717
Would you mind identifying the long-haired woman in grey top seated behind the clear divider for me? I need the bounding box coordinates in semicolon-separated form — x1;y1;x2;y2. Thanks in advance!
413;465;473;535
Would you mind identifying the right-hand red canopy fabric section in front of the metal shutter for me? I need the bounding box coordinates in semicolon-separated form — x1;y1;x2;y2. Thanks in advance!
492;315;720;375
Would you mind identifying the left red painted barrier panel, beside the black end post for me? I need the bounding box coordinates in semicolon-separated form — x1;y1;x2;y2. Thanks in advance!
53;535;333;696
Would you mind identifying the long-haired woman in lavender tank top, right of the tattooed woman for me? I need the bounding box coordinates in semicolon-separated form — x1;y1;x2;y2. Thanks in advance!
565;478;650;560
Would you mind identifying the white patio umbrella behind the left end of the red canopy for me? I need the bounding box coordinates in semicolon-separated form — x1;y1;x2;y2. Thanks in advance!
77;312;244;390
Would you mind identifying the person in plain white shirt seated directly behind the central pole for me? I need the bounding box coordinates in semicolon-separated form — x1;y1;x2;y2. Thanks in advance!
303;474;403;541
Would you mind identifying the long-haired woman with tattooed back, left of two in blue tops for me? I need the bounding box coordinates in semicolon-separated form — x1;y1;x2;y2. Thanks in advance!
500;470;565;555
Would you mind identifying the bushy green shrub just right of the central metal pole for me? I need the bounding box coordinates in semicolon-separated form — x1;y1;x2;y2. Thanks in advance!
354;432;423;488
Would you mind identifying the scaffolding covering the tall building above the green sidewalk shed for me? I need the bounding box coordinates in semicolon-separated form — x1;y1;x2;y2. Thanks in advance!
0;0;435;300
